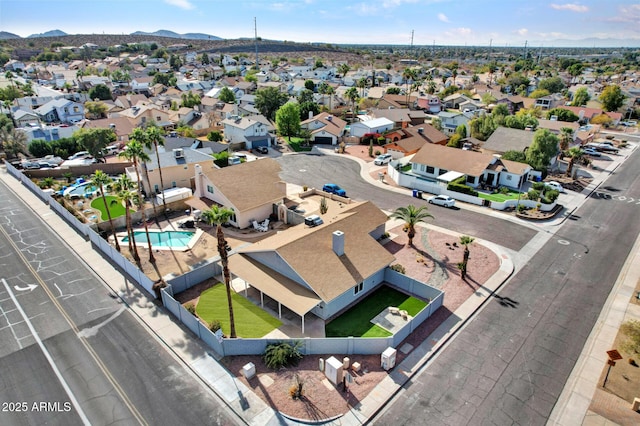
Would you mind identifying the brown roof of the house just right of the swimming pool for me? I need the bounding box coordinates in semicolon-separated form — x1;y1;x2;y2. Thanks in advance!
205;158;286;212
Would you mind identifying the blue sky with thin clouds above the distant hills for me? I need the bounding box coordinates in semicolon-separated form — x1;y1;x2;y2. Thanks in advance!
0;0;640;46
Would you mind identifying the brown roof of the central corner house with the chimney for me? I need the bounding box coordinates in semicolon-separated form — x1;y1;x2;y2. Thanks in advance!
241;201;395;302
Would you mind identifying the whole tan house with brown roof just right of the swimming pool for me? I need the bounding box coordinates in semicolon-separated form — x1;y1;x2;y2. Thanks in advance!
192;158;286;229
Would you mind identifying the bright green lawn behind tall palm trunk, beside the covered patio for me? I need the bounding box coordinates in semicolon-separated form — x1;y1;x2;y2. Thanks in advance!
196;283;282;338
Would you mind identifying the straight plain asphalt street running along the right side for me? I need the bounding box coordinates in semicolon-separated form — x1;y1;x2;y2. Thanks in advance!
372;148;640;426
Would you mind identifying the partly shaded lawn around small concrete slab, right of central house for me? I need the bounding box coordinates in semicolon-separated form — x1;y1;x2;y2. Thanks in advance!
325;286;427;337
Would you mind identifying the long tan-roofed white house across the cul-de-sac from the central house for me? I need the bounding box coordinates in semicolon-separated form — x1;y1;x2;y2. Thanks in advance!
411;144;531;188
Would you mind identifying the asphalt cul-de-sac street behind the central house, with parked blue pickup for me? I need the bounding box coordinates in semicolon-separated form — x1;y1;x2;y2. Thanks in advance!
277;154;536;251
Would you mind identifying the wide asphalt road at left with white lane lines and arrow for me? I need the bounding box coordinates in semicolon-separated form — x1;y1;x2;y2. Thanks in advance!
0;182;242;426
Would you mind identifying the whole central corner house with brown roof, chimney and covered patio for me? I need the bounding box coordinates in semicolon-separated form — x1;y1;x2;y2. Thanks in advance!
229;201;395;322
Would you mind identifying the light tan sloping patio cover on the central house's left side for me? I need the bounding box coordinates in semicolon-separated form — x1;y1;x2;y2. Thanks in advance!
229;254;321;317
